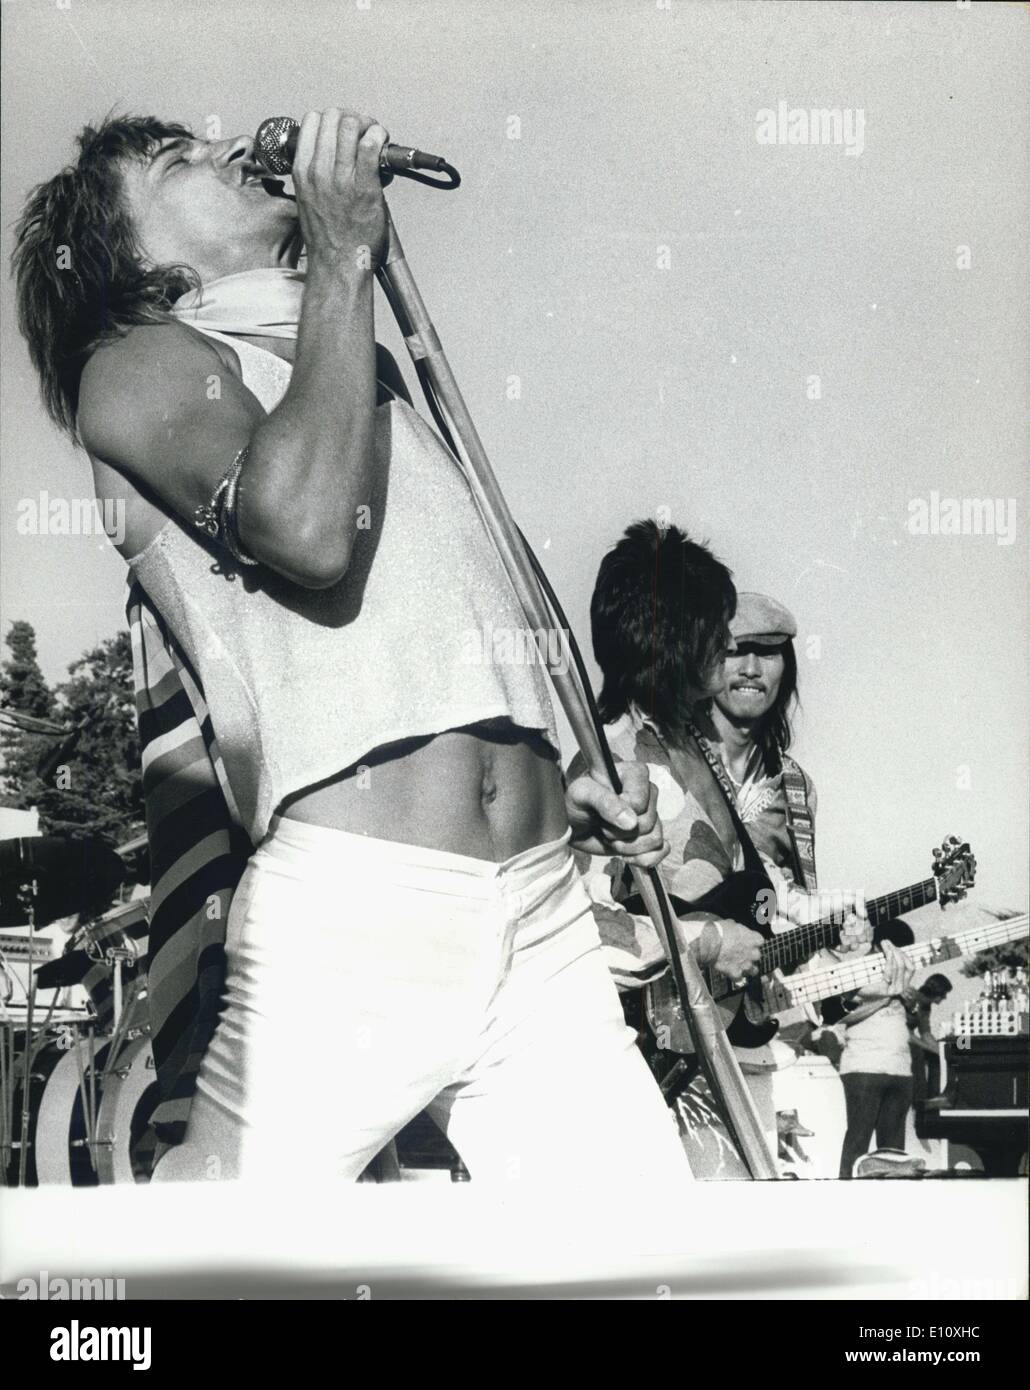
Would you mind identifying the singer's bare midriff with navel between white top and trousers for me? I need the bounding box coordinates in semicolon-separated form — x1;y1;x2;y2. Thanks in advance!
279;720;569;863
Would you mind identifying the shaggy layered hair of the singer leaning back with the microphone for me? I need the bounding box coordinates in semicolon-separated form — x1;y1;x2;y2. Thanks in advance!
11;115;199;438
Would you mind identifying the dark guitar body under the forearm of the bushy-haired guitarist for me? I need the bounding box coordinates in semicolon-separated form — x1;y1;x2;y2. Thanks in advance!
639;870;780;1055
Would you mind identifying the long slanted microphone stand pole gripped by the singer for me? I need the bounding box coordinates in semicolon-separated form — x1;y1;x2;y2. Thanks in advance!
377;214;778;1179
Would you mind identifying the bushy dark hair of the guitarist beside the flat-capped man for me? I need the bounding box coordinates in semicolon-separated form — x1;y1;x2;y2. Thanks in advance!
591;521;737;738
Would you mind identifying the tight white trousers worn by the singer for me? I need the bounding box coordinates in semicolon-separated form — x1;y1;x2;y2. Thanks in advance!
154;819;691;1197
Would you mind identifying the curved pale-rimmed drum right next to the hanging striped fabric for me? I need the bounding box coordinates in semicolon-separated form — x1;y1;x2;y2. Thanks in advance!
97;1036;160;1183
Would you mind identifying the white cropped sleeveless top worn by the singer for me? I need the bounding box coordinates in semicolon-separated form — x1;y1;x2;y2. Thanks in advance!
129;329;559;844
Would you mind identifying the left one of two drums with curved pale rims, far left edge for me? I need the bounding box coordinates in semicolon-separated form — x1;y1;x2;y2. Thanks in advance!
7;1030;106;1187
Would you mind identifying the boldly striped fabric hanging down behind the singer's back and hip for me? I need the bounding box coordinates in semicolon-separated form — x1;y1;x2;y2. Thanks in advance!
125;577;252;1156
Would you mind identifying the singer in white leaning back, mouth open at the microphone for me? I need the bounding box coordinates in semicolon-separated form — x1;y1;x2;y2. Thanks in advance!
14;108;688;1191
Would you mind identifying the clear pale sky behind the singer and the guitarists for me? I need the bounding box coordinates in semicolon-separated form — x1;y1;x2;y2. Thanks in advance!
0;0;1030;908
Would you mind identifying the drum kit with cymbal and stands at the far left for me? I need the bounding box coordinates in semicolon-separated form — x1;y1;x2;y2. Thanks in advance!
0;835;157;1187
